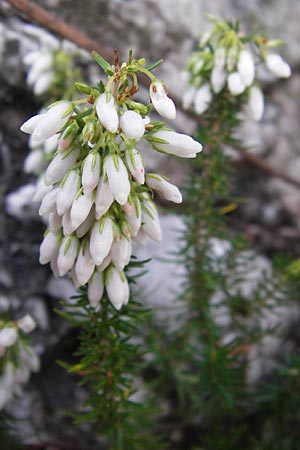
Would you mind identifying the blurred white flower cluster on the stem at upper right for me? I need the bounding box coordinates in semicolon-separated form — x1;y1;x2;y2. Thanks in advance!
183;19;291;121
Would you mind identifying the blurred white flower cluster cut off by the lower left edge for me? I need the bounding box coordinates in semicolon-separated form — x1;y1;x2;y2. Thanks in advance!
0;314;40;410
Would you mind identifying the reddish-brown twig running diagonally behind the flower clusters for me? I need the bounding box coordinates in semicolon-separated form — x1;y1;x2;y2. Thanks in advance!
7;0;300;189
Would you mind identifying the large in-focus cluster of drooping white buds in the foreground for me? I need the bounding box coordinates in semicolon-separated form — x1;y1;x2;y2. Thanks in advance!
21;54;202;309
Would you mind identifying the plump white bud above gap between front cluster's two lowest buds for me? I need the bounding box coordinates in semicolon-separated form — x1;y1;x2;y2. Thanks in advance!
90;217;114;265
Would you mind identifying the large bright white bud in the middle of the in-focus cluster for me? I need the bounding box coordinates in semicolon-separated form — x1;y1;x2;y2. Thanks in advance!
105;155;130;205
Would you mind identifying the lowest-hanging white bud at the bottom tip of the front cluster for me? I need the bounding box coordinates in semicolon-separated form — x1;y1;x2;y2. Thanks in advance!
105;267;129;310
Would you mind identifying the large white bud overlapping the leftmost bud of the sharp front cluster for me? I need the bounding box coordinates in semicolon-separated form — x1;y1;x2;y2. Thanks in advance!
32;100;73;141
